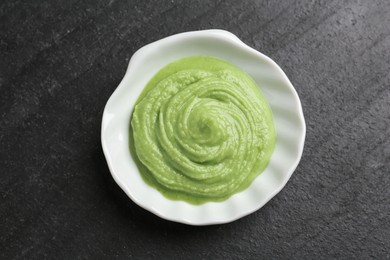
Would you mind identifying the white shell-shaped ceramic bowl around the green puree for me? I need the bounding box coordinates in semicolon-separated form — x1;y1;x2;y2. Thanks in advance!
101;30;306;225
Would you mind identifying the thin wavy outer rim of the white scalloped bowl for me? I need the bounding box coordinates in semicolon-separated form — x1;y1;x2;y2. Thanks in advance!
101;29;306;226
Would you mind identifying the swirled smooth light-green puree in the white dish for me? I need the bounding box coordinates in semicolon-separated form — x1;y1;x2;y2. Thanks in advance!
130;56;276;204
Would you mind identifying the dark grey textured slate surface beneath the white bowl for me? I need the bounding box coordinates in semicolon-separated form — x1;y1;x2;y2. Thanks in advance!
0;0;390;259
